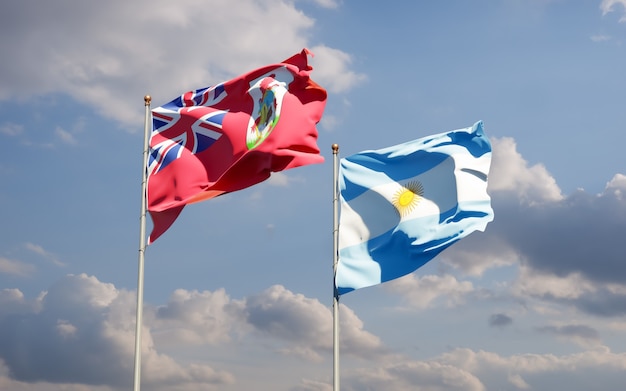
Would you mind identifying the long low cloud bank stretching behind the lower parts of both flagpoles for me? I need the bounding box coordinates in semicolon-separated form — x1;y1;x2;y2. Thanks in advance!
0;274;392;391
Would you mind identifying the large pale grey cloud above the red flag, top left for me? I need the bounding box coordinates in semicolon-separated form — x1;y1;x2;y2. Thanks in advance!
0;0;359;129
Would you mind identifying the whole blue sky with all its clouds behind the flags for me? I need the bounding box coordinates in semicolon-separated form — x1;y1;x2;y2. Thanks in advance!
0;0;626;391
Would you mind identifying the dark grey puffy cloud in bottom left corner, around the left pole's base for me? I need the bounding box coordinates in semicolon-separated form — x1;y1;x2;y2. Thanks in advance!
0;274;234;390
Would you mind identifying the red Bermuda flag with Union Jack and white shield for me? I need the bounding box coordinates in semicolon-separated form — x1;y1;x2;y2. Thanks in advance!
146;49;326;243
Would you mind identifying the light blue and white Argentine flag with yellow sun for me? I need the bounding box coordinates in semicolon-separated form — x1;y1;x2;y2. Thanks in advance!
335;121;493;295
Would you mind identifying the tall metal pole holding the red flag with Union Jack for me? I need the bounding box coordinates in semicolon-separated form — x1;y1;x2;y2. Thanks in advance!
133;95;152;391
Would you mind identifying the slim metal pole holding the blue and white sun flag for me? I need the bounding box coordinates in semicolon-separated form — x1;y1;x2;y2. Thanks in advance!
332;144;339;391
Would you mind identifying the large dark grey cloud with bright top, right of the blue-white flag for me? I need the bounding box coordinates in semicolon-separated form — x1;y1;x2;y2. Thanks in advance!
436;138;626;316
